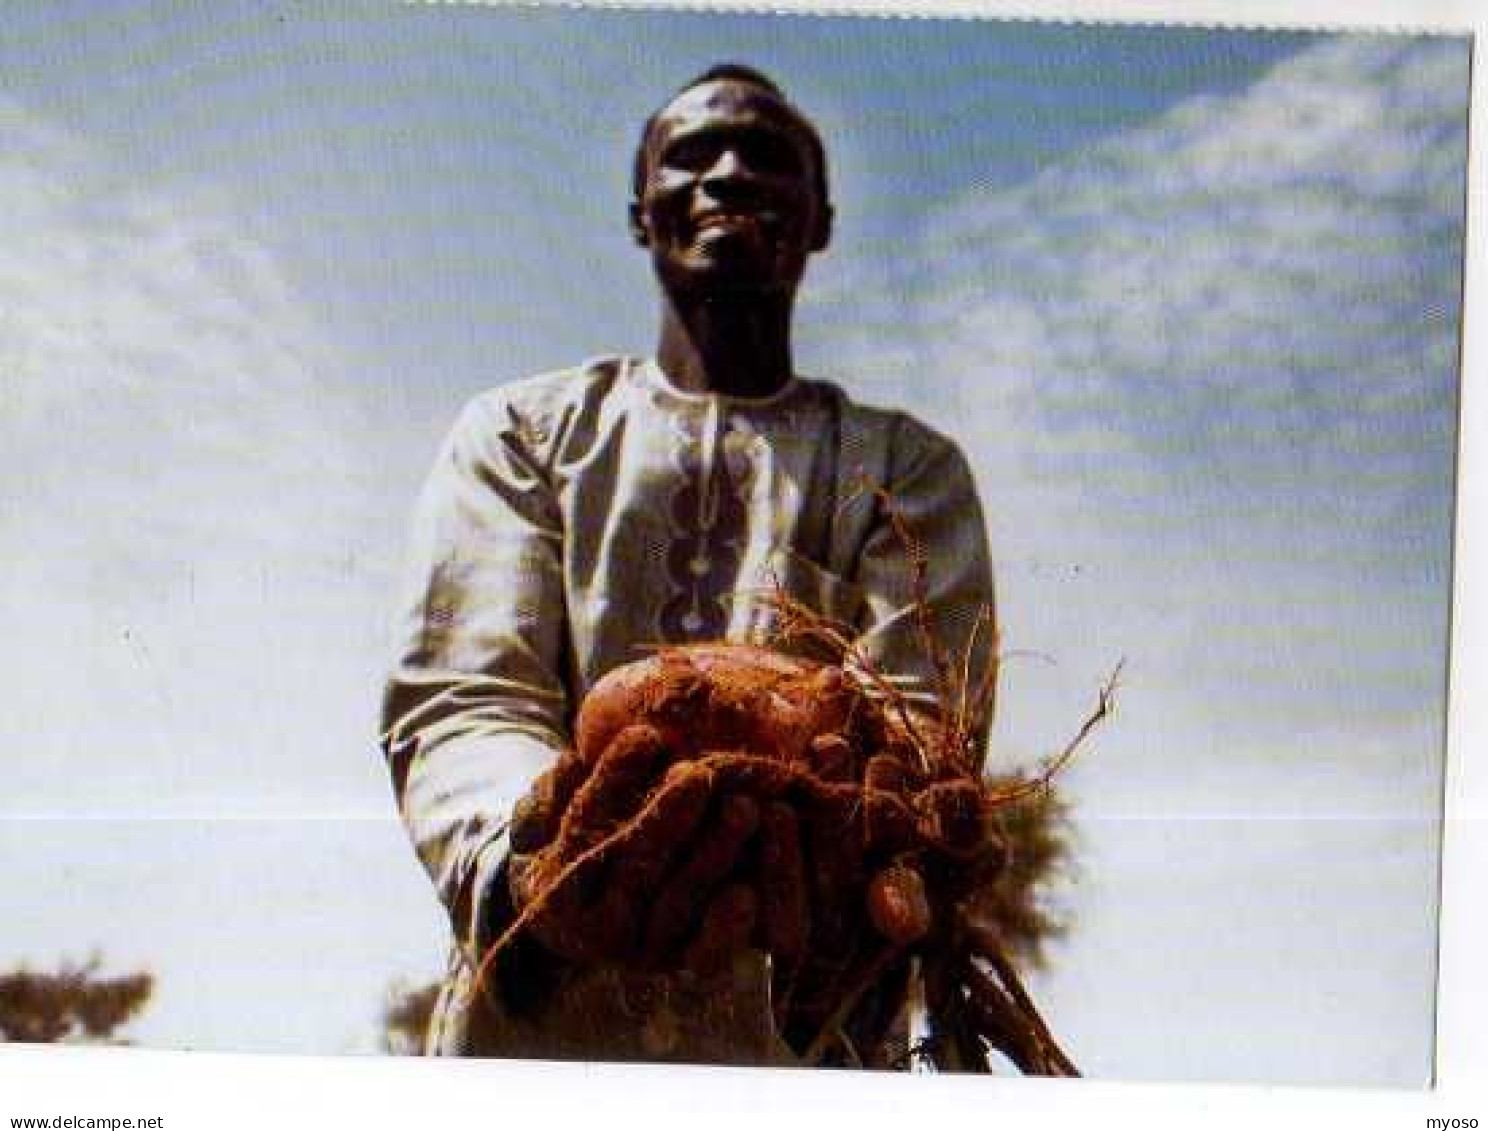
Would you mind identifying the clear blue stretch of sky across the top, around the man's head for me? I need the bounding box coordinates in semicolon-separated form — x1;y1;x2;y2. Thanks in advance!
0;4;1306;431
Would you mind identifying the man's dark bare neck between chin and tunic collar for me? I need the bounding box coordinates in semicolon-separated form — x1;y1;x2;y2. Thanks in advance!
656;295;792;397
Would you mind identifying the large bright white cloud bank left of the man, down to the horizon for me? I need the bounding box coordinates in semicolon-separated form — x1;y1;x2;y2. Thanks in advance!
0;94;443;1052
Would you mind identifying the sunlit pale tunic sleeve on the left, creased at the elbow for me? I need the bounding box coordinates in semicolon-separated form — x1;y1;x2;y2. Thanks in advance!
382;394;568;941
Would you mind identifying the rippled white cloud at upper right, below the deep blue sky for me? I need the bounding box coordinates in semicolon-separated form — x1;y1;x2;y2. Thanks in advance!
918;37;1467;518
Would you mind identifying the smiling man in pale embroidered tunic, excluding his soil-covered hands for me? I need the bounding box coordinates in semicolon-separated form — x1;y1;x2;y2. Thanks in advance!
384;65;994;1060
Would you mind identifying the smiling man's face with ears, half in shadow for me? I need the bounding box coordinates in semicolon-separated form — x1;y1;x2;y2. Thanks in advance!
632;79;830;293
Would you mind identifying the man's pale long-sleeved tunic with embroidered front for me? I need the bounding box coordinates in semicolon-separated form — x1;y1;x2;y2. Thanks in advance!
382;359;995;1059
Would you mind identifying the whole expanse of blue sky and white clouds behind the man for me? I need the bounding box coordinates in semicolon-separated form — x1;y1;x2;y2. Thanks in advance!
0;3;1467;1085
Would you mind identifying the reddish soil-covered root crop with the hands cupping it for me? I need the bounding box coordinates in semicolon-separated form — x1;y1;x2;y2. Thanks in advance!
487;630;1107;1074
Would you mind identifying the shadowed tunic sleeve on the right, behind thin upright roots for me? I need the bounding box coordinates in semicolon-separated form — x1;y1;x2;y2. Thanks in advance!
856;418;997;754
